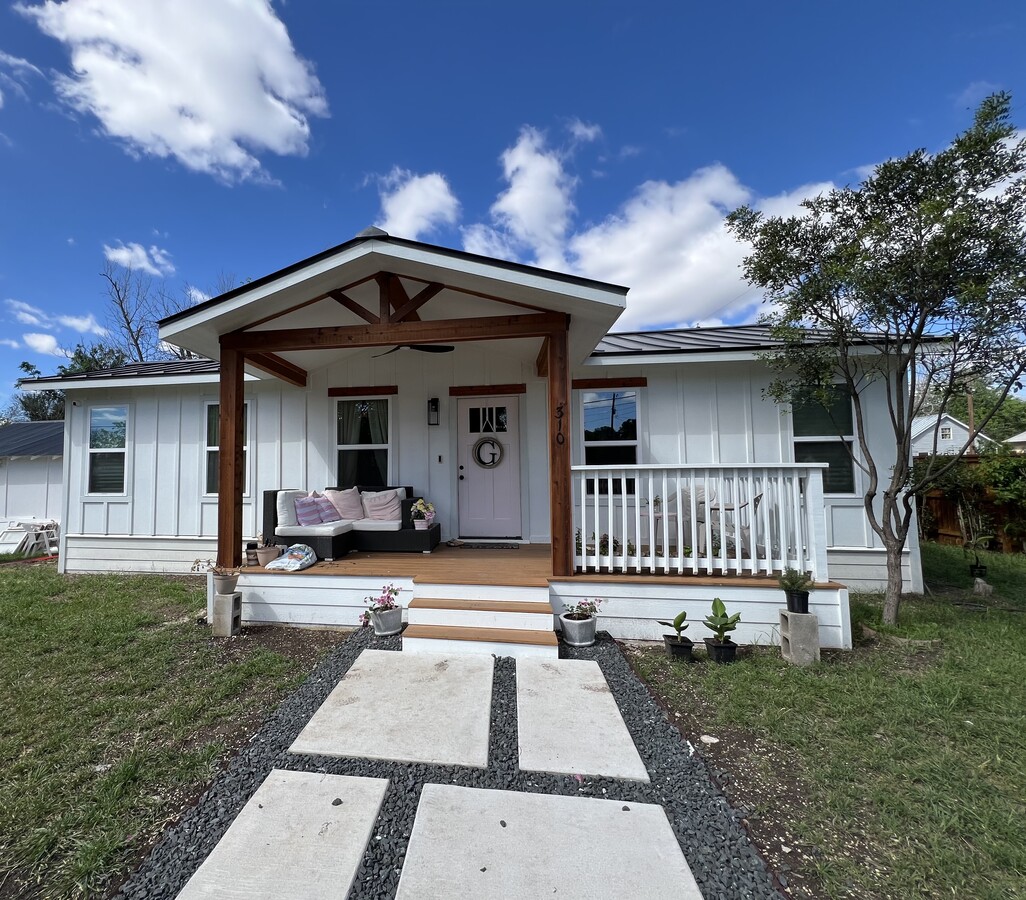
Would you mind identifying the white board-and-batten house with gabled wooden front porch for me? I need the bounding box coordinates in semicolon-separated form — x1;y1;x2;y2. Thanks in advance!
26;229;921;647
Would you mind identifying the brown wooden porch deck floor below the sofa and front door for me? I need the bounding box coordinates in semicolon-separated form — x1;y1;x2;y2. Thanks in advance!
250;544;841;588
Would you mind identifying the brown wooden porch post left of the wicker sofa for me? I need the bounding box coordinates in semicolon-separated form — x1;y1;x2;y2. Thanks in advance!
218;347;245;565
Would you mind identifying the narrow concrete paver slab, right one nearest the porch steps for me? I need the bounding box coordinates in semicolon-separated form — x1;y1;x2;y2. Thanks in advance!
516;659;648;781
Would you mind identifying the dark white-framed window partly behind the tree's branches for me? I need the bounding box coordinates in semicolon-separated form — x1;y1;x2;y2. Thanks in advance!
791;385;855;494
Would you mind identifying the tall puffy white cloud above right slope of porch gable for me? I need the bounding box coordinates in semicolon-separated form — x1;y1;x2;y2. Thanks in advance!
464;127;577;269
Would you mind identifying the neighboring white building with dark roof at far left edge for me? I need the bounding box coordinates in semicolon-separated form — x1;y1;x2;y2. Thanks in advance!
0;422;64;521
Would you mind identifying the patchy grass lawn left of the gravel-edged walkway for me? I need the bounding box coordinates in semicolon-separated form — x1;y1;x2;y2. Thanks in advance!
0;563;341;898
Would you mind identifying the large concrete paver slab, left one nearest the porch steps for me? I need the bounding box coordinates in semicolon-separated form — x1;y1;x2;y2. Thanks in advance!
289;650;495;769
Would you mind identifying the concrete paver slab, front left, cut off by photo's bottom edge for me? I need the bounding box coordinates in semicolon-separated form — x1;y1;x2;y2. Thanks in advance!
179;769;388;900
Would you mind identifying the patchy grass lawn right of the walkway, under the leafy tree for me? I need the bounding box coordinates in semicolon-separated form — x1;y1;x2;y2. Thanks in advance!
628;545;1026;900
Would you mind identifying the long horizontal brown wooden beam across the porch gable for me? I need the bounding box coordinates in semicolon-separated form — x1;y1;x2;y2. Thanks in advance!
221;313;569;355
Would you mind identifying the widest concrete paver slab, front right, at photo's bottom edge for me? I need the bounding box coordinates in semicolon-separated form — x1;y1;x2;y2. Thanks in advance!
396;784;702;900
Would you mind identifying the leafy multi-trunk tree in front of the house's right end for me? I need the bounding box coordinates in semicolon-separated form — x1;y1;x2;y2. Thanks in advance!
727;93;1026;623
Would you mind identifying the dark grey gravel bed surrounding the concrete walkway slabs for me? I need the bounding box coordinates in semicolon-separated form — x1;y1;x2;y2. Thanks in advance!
117;628;782;900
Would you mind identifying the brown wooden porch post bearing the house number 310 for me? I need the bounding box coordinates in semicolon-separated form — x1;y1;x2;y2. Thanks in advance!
546;329;574;577
